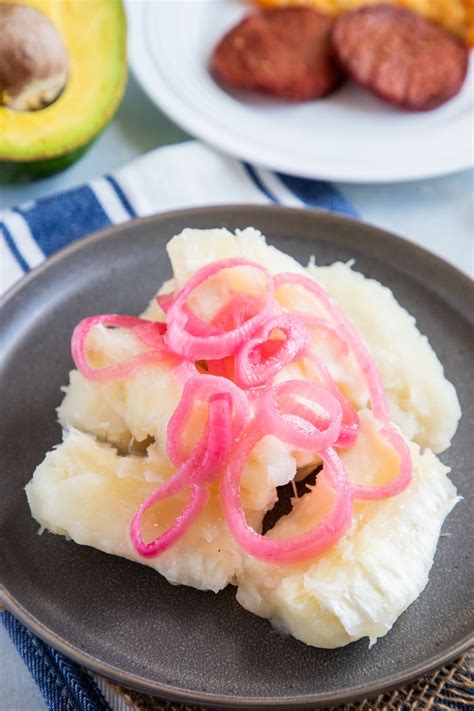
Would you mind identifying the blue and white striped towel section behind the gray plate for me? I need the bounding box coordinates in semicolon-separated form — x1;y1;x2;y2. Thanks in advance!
0;141;355;292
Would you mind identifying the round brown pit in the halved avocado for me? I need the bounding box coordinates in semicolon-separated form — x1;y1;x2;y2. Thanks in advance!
0;2;68;111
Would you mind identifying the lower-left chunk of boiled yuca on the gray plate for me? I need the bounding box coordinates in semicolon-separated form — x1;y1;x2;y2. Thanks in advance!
26;430;241;592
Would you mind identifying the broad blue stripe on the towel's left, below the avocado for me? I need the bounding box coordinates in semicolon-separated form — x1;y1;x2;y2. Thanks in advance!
15;185;110;257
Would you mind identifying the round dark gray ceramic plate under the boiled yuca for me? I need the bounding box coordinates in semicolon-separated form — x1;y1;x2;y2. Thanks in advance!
0;206;474;708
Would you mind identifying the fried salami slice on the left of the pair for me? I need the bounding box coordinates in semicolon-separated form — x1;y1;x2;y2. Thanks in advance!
211;7;343;101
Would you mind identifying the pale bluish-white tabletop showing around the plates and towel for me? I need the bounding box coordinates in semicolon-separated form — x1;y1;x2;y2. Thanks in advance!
0;62;474;711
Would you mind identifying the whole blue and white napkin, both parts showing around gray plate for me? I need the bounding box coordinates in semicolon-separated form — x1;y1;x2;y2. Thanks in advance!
0;141;356;711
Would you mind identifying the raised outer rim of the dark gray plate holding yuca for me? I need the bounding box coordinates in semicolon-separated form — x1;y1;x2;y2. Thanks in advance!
0;203;474;709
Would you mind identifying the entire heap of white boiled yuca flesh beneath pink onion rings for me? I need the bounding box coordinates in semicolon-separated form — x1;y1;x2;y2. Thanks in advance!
27;228;460;647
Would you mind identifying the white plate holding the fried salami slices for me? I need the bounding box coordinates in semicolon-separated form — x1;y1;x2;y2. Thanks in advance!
127;0;474;182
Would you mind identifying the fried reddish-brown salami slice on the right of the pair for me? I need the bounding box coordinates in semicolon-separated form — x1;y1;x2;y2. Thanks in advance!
332;5;468;111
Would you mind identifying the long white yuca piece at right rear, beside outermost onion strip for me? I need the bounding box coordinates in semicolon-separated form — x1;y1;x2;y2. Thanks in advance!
308;262;461;452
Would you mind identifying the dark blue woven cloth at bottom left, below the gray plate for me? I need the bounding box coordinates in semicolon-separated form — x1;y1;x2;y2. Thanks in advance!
1;612;111;711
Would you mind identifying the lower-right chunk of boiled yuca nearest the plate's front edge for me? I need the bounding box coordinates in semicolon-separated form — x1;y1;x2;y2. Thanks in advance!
237;412;458;648
